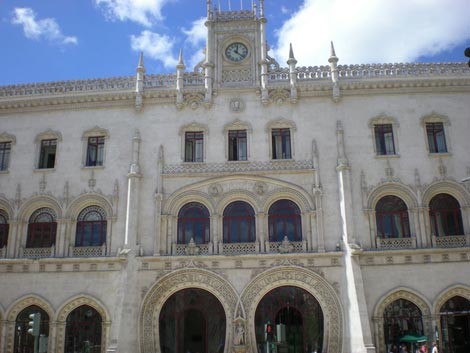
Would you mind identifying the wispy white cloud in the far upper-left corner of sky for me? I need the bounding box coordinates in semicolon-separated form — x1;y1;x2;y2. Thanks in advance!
11;8;78;44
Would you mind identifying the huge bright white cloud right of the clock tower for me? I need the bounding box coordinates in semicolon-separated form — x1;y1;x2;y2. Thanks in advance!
273;0;470;65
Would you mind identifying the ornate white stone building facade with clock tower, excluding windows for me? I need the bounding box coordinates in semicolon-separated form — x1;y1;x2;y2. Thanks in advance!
0;2;470;353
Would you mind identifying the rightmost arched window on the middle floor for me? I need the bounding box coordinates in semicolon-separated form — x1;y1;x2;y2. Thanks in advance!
429;194;464;236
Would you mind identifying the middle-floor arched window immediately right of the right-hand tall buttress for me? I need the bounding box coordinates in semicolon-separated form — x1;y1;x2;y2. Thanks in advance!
375;196;410;238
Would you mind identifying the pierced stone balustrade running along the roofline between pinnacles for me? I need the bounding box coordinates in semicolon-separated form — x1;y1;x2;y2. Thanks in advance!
0;62;470;100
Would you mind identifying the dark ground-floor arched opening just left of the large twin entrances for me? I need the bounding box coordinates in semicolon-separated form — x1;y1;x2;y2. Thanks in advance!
65;305;103;353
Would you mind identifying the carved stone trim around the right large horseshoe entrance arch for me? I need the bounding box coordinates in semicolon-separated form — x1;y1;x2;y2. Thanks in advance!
241;266;344;353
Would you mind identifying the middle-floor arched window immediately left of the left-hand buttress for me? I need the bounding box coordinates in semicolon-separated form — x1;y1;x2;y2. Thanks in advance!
75;206;107;247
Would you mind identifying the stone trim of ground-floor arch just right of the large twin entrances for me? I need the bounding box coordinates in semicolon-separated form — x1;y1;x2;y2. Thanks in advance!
374;288;431;353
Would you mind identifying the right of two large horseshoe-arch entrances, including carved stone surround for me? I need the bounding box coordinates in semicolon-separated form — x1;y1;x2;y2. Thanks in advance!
242;266;343;353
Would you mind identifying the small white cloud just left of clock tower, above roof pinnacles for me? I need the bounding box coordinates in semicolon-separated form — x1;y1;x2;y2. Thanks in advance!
131;30;178;69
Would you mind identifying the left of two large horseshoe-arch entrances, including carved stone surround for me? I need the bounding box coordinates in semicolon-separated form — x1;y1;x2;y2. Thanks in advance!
139;268;238;353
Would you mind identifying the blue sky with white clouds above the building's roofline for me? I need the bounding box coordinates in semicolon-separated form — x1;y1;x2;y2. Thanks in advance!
0;0;470;85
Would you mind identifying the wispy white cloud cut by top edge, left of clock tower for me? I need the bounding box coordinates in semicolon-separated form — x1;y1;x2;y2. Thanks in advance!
95;0;169;27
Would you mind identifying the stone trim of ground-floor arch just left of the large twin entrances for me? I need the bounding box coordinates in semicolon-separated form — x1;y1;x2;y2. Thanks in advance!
56;296;111;353
